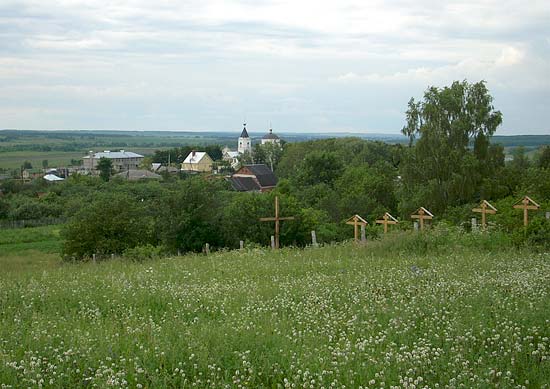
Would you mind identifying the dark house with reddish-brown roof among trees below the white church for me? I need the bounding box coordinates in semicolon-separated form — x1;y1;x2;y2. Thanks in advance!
228;164;277;192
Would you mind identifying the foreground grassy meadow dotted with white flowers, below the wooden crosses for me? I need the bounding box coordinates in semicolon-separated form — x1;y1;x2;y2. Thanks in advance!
0;227;550;387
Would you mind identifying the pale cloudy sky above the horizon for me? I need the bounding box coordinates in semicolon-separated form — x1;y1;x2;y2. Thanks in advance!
0;0;550;135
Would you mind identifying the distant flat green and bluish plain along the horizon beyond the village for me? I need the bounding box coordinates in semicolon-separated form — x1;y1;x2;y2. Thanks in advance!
0;128;550;169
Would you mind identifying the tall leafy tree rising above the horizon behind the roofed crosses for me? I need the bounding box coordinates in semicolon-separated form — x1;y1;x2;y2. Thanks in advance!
402;81;503;211
